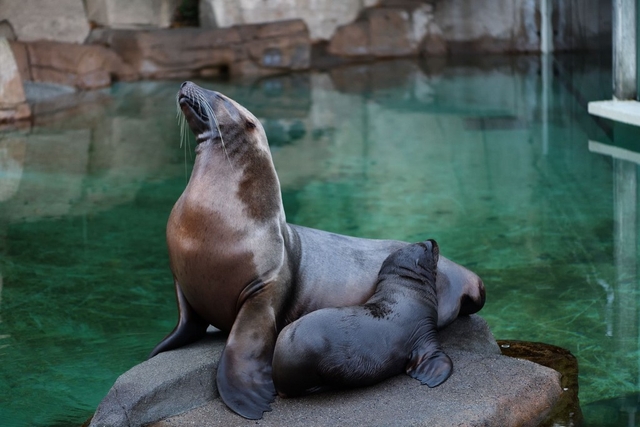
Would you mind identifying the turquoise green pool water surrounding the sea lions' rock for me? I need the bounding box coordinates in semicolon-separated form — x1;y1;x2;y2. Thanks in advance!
0;55;640;426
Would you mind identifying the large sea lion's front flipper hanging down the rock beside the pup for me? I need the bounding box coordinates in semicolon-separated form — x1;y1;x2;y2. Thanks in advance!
217;289;277;420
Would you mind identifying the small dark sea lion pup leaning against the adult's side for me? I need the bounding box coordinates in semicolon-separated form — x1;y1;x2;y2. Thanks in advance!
273;240;453;397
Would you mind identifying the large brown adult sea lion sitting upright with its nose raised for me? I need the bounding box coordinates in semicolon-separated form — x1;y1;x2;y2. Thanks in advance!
150;82;485;419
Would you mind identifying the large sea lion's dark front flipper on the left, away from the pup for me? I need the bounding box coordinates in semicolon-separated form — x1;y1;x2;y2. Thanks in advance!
148;278;209;359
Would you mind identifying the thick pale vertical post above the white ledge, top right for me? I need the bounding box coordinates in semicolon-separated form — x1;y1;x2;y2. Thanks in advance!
612;0;638;100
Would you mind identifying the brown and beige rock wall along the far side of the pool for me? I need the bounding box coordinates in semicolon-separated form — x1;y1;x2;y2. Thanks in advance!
0;0;611;125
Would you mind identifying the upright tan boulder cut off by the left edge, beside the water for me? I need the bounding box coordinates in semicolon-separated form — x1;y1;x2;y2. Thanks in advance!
0;38;31;123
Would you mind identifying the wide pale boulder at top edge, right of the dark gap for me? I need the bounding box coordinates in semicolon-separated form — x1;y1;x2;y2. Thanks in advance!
200;0;379;41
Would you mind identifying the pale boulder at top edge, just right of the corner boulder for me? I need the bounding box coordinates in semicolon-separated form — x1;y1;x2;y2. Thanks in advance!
85;0;180;29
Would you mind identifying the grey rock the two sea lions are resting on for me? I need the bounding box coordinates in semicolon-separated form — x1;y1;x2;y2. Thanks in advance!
90;315;564;427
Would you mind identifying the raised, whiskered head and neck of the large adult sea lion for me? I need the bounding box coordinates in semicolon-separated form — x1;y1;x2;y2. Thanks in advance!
176;82;285;224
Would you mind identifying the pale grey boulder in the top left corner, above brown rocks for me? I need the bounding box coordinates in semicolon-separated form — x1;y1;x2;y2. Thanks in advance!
0;0;89;43
